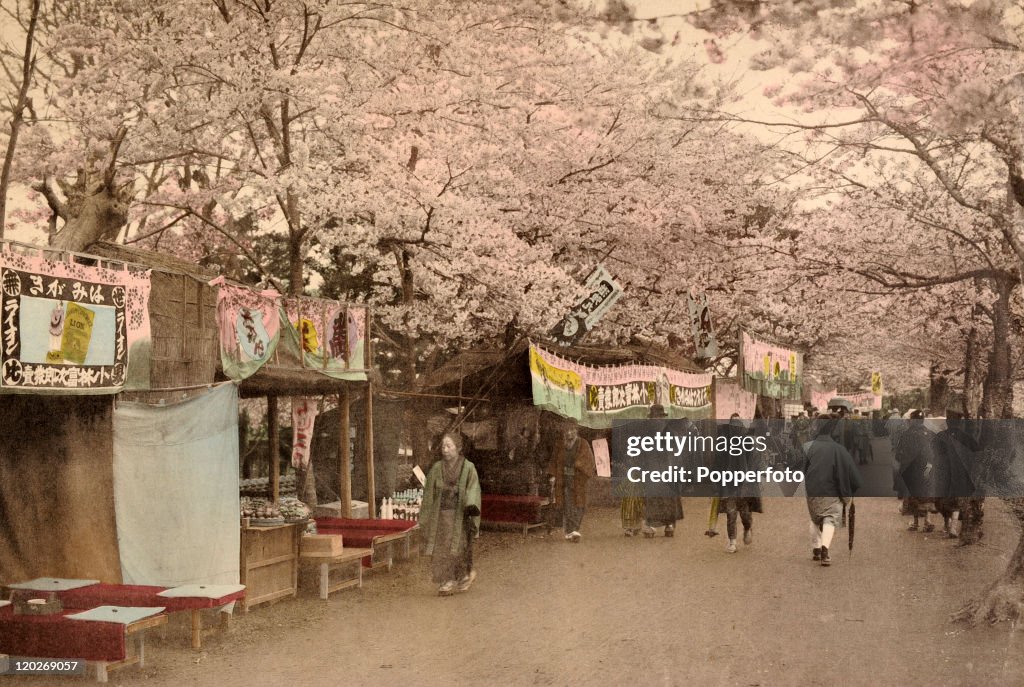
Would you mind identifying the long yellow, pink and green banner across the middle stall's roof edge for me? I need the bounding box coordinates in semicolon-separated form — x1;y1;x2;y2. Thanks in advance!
529;345;712;429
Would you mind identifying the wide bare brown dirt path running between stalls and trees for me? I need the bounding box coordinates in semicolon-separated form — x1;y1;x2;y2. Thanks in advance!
7;444;1024;687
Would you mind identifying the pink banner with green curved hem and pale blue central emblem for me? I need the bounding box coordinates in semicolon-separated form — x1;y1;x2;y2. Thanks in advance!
210;276;281;381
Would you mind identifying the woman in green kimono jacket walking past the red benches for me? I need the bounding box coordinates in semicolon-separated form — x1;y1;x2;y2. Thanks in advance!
420;432;480;596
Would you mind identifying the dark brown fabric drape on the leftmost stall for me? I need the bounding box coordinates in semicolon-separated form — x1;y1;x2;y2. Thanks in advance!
0;396;121;584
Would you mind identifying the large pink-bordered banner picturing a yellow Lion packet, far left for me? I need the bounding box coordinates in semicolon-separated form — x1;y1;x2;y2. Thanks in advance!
0;251;151;394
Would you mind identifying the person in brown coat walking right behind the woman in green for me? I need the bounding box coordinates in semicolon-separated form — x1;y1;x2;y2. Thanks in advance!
548;423;597;544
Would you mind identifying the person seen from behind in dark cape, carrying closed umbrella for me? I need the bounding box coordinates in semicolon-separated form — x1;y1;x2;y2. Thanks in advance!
804;416;863;566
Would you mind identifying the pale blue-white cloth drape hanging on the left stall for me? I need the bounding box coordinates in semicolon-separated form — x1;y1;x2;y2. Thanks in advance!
114;384;240;587
